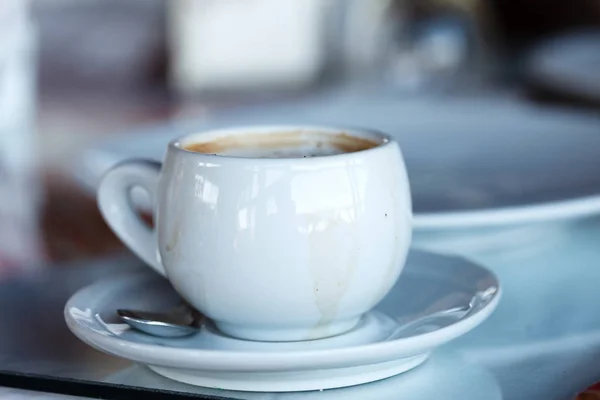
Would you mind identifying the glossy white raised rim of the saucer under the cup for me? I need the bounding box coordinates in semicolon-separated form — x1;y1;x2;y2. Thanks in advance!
64;256;503;372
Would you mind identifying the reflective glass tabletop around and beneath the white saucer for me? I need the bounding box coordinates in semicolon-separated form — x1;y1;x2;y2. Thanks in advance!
0;219;600;400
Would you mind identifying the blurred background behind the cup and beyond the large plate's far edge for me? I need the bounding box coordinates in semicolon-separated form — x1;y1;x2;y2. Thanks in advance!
0;0;600;268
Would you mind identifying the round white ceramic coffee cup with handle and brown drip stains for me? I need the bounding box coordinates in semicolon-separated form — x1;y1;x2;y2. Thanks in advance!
98;126;412;341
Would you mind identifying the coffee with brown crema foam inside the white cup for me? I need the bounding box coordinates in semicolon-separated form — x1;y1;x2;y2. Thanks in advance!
183;132;380;158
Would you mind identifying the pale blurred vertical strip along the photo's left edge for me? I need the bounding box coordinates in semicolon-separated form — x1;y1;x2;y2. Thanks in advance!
0;0;42;276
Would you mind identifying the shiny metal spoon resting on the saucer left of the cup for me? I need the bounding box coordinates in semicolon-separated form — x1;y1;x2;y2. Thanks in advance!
117;308;204;338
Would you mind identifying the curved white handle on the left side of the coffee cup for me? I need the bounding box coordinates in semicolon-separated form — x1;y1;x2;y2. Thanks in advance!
97;160;166;276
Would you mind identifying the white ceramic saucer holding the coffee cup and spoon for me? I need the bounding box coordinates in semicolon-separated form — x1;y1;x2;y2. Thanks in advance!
65;251;500;392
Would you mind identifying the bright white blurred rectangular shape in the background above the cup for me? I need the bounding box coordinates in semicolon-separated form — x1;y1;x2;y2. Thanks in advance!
168;0;327;93
